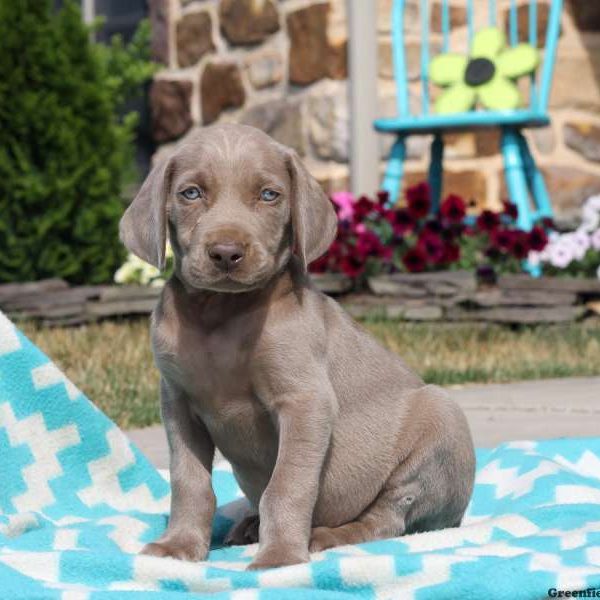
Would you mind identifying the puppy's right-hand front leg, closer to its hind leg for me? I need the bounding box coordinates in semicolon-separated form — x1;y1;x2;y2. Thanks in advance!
249;391;333;569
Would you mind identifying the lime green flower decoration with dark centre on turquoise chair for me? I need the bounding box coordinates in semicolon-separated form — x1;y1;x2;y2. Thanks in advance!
430;27;540;114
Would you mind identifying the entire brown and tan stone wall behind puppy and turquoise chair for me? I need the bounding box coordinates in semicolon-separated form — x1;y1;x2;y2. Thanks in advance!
150;0;600;217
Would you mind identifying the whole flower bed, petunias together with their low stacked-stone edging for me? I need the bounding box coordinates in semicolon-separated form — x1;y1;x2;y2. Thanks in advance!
7;184;600;325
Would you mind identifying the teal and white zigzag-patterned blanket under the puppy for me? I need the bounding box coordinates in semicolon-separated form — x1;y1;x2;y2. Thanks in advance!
0;313;600;600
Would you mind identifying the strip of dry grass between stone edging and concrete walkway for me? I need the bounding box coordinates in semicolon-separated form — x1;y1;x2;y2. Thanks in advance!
22;319;600;428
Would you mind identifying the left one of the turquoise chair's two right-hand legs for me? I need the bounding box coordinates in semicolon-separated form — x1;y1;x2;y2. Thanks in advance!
502;128;541;277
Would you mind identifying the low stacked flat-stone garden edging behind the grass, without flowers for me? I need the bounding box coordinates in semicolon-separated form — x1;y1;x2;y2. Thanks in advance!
0;271;600;326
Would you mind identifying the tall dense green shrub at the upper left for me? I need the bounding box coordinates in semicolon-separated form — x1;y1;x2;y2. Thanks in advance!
0;0;154;283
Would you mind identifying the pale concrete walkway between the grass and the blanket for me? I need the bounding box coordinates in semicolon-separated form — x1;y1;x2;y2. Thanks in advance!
128;377;600;469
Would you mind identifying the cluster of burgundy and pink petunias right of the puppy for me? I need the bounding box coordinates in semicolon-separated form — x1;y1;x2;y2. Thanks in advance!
311;183;552;289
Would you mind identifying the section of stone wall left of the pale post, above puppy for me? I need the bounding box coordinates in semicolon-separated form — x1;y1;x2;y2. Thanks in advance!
150;0;349;191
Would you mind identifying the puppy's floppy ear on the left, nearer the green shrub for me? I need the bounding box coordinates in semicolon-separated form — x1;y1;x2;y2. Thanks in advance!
119;159;171;269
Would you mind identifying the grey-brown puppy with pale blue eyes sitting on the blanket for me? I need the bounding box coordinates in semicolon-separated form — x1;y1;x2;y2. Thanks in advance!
121;125;475;569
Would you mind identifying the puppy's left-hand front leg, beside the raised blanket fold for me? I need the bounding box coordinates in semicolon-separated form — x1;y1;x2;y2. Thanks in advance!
142;379;216;561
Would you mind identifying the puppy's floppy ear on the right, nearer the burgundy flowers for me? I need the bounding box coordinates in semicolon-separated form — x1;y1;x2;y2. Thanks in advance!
288;150;337;269
